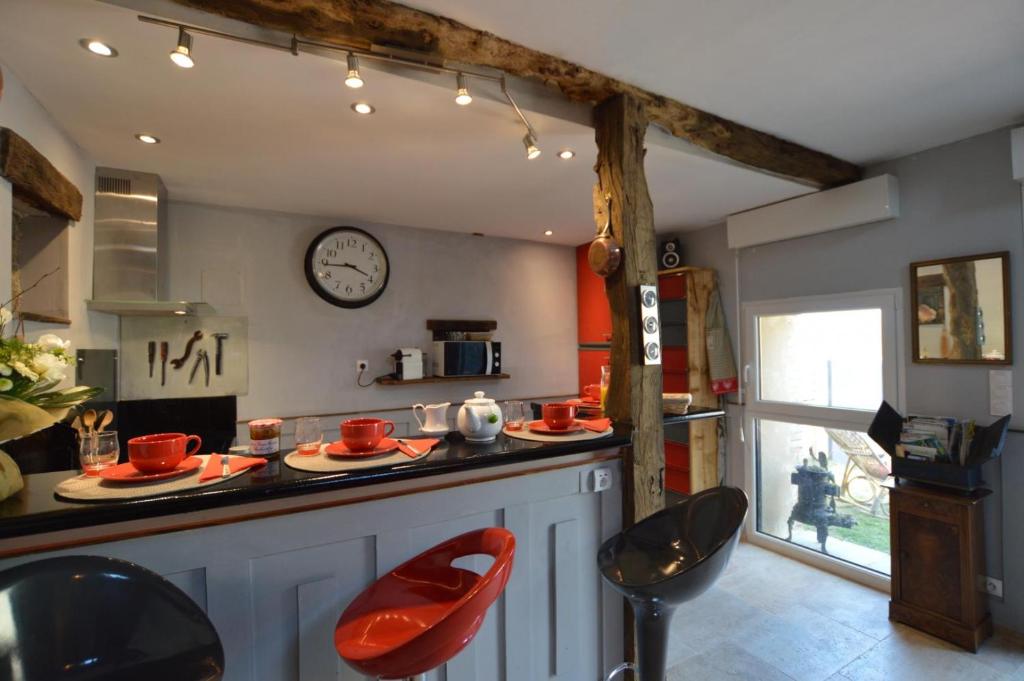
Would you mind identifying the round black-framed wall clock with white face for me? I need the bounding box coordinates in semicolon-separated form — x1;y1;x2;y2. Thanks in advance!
305;227;390;307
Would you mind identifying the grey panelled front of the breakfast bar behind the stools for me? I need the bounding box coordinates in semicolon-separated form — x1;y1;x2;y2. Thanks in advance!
0;450;623;681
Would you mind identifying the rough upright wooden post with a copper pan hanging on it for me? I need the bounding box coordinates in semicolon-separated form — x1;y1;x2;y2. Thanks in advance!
594;94;665;526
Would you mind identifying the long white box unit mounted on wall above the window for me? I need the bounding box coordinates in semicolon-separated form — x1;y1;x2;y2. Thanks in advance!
726;175;899;248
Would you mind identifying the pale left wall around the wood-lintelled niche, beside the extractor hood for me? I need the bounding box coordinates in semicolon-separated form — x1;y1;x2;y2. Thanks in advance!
0;59;118;348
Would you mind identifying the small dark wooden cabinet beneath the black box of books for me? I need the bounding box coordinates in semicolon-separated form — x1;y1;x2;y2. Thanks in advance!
889;484;992;651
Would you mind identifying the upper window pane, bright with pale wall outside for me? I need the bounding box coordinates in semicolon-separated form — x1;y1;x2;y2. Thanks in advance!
758;308;883;412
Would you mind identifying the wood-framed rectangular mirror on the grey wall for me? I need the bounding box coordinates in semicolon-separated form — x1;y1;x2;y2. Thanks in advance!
910;251;1013;365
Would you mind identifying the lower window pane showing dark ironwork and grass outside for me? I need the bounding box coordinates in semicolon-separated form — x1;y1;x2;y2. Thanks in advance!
756;419;892;574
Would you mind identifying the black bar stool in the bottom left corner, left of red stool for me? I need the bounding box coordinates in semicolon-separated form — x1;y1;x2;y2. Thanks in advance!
0;556;224;681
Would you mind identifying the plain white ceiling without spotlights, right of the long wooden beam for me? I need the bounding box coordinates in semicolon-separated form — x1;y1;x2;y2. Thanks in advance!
403;0;1024;164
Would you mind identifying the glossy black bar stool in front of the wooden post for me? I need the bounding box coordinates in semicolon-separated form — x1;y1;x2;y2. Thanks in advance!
597;487;748;681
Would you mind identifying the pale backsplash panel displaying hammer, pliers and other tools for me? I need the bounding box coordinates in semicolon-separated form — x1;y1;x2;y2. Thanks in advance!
120;315;249;399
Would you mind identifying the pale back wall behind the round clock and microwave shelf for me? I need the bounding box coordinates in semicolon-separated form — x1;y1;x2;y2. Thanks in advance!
168;199;578;419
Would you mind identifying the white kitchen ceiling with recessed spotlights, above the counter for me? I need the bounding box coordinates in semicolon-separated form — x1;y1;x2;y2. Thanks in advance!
0;0;808;244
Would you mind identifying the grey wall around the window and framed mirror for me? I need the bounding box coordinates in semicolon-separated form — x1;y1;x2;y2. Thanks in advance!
667;124;1024;630
